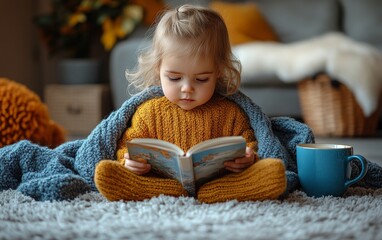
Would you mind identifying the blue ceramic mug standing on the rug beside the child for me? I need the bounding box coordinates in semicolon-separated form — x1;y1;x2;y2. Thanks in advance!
296;143;368;197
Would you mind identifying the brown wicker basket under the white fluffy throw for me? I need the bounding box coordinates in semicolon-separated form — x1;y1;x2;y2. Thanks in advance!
298;74;382;137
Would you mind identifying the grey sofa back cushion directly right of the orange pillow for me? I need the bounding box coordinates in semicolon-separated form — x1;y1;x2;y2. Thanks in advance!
250;0;340;43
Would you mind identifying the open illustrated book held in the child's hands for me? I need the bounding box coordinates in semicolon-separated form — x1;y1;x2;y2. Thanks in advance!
127;136;246;196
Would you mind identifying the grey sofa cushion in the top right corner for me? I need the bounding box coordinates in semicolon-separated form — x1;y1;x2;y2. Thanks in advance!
341;0;382;51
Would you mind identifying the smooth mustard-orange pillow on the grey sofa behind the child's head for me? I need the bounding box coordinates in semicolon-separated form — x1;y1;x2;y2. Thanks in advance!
210;1;278;45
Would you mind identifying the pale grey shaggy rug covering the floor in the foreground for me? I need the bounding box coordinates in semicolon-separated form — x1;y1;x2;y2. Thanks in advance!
0;188;382;240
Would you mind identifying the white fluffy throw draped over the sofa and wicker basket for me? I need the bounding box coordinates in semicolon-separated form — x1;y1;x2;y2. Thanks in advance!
233;32;382;117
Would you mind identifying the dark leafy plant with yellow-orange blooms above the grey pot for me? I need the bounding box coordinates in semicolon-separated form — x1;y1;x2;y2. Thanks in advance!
34;0;143;57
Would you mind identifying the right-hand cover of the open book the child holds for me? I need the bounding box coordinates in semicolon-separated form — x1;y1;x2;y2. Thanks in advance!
192;142;246;188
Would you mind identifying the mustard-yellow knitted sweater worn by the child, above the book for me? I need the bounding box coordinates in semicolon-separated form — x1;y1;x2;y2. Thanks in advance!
117;95;257;161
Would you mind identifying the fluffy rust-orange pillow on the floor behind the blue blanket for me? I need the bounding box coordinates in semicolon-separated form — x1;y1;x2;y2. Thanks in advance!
0;78;66;148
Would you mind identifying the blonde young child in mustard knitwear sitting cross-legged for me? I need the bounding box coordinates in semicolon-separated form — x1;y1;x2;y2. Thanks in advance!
94;5;286;203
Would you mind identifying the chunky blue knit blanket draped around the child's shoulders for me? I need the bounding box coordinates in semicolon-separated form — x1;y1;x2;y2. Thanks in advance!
0;87;382;201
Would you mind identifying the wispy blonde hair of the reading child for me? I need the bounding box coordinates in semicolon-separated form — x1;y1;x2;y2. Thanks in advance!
126;5;241;96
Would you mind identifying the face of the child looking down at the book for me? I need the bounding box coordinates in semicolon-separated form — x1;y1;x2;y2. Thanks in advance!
159;55;217;110
